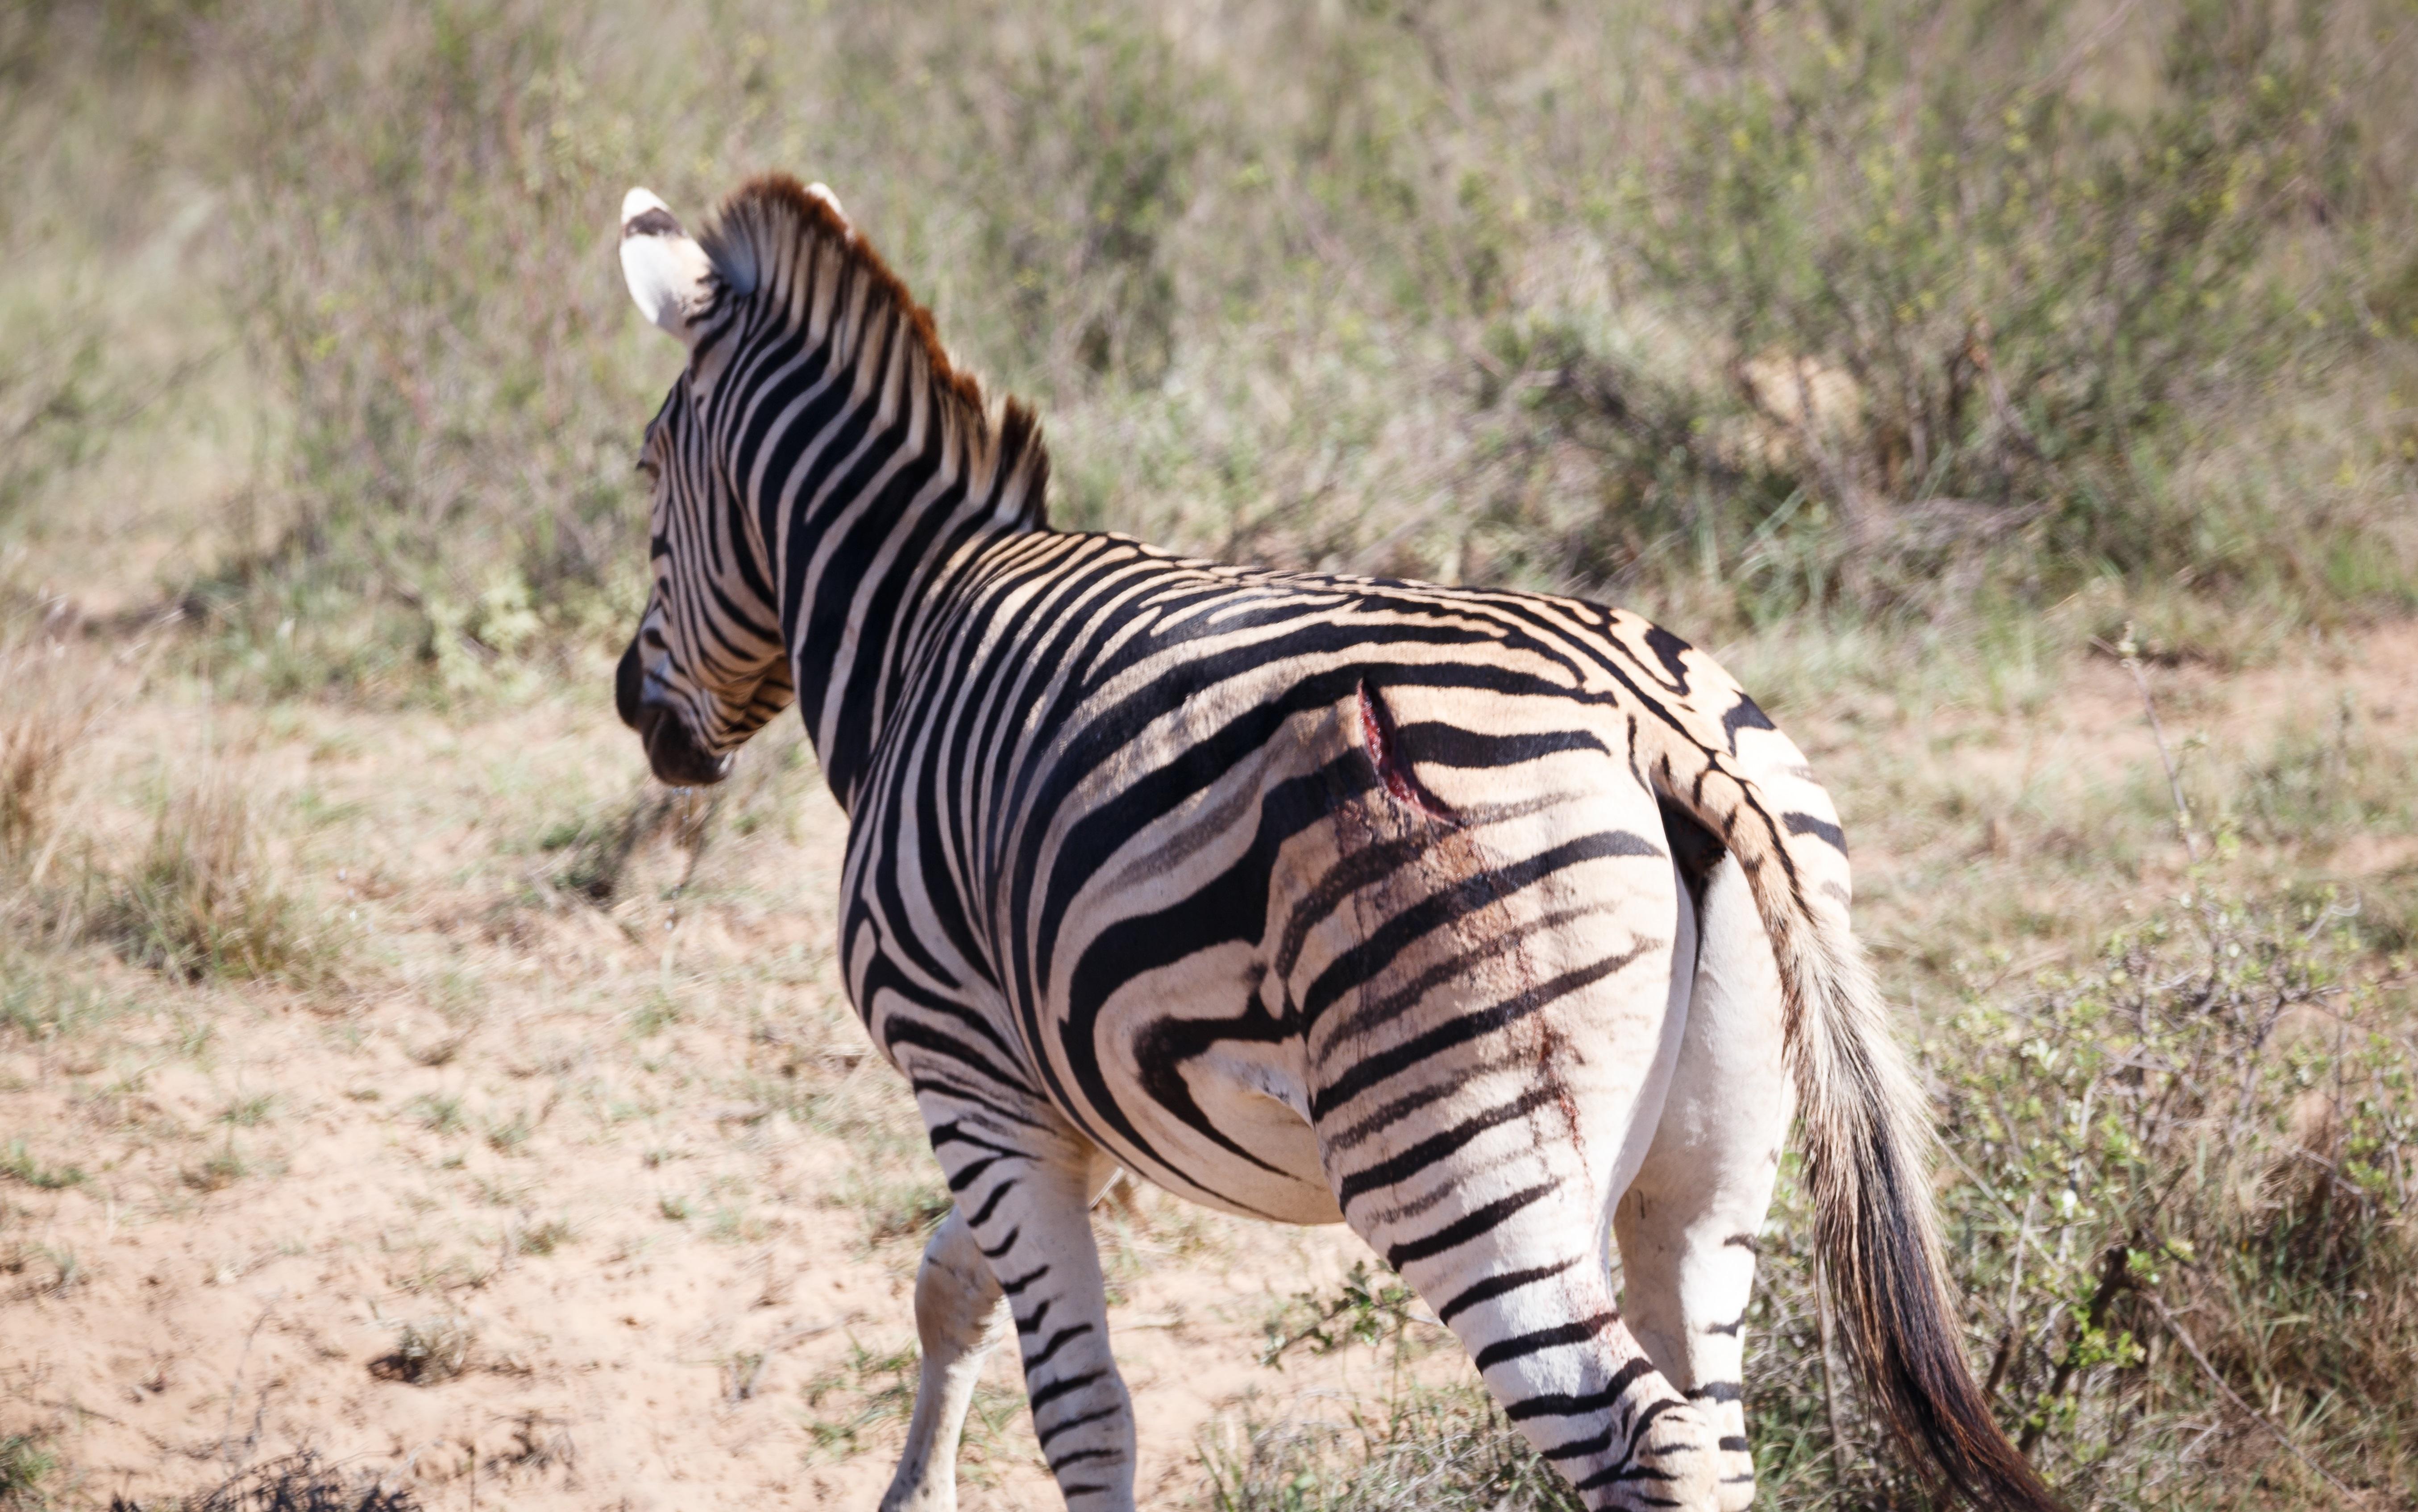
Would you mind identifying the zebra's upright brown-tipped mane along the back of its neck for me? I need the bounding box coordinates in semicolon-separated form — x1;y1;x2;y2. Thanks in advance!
696;174;1049;529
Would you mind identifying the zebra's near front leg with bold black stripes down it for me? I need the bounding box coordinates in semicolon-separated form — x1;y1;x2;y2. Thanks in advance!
924;1099;1134;1512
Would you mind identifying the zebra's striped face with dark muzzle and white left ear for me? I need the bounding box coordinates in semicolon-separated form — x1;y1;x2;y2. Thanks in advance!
614;186;798;787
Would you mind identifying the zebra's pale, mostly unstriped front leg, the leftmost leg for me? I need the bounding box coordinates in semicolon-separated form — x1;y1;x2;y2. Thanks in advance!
883;1208;1008;1512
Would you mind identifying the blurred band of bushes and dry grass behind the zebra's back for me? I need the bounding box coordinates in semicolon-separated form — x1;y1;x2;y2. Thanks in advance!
0;0;2418;696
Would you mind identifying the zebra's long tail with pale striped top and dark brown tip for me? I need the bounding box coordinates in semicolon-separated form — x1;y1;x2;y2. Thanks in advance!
1656;756;2060;1512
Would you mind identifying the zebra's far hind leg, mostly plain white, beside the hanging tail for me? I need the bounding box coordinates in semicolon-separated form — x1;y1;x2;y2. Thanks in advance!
1613;860;1794;1512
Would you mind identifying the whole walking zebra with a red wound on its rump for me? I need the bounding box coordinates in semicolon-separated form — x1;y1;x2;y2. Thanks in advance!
614;176;2055;1512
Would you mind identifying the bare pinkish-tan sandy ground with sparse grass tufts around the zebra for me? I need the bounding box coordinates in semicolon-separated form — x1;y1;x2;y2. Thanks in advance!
0;626;2418;1510
